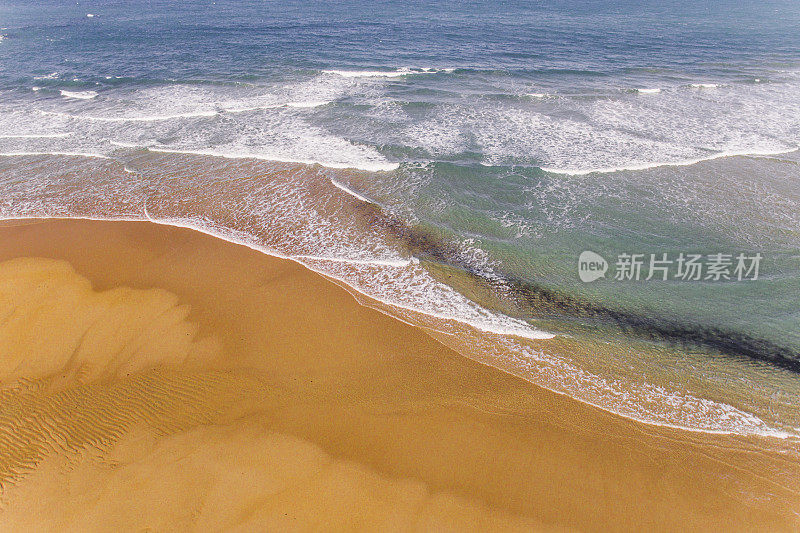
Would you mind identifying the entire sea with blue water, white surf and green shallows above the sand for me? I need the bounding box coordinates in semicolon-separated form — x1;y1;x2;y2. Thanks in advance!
0;0;800;438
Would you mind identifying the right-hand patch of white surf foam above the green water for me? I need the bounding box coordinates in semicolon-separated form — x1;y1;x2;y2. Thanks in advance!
400;76;800;174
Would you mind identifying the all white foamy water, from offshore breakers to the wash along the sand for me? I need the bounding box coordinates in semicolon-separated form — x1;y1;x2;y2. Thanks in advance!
0;69;800;437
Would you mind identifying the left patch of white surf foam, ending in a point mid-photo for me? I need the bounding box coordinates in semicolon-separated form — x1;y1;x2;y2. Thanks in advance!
34;81;399;171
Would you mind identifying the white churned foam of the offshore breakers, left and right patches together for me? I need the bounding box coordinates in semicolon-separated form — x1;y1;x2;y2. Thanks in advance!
15;68;800;180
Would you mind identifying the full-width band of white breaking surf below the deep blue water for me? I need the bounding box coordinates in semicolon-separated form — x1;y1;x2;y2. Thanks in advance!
6;68;800;175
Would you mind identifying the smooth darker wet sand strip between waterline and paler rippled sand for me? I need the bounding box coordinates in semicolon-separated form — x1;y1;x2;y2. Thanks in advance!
0;219;800;530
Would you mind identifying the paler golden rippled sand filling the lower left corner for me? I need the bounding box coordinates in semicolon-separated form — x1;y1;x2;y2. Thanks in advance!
0;258;536;531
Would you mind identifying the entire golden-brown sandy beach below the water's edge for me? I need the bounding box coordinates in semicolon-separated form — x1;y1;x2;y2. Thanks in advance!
0;220;800;531
